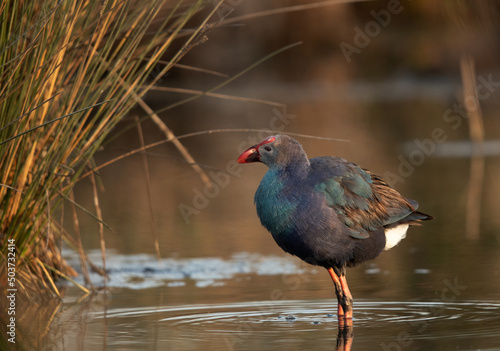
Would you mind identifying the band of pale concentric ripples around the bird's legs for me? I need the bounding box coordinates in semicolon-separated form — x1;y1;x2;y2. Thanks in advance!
95;300;500;336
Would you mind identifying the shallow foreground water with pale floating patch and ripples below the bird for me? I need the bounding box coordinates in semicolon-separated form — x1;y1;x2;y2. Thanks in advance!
27;248;500;350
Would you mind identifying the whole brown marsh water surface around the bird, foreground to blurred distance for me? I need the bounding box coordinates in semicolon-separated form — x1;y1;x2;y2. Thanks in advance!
5;2;500;351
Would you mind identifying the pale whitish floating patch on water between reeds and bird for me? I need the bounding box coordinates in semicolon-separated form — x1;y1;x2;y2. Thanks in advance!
61;250;314;289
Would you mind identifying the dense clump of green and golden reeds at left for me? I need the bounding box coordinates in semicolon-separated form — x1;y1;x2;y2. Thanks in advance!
0;0;215;294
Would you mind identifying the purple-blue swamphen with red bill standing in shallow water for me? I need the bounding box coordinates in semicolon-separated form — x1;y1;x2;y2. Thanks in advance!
238;134;432;326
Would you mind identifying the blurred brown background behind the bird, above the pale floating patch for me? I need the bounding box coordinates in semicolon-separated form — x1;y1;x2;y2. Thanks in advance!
77;1;500;272
